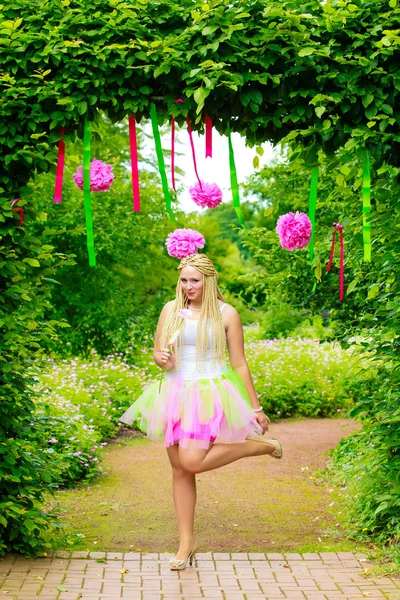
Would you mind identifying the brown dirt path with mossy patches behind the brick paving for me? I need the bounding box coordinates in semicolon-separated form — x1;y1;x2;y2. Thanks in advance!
51;419;356;552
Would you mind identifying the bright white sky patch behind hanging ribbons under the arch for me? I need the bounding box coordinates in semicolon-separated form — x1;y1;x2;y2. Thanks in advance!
142;127;274;213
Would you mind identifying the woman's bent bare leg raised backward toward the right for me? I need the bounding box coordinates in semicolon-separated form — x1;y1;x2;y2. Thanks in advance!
179;440;275;473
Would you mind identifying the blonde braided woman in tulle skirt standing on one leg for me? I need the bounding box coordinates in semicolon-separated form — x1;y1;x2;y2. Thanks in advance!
120;254;282;570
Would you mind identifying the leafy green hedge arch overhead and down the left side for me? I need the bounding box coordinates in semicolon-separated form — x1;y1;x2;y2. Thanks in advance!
0;0;400;551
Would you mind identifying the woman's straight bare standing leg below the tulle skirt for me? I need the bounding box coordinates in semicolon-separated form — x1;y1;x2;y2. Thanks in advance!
167;444;196;559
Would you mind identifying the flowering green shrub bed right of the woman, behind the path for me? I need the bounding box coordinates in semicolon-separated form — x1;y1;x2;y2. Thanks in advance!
246;338;362;418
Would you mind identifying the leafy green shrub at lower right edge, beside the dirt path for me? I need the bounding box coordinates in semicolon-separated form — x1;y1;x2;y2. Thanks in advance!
324;360;400;544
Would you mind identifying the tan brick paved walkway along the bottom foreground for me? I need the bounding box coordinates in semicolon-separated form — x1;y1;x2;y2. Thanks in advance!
0;552;400;600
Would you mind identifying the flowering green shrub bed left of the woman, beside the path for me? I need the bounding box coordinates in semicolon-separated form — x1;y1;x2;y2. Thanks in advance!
30;349;158;486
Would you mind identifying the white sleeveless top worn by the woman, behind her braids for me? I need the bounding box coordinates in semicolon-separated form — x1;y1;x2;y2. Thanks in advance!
166;304;227;380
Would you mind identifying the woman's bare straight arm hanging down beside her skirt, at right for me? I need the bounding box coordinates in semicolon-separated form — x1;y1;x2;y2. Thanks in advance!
224;305;261;409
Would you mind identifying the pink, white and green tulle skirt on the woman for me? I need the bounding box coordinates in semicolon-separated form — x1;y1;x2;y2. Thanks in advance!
120;367;262;449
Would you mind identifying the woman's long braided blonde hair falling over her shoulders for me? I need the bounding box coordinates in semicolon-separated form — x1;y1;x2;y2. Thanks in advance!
161;254;226;370
